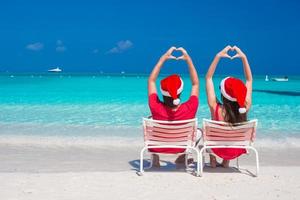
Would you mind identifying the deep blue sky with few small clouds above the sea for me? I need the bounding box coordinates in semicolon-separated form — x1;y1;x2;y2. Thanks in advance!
0;0;300;75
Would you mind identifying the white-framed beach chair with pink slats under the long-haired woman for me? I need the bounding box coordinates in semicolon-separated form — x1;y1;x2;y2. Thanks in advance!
200;119;259;176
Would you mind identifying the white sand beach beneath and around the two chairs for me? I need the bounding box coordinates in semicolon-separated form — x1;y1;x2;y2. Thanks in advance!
0;141;300;200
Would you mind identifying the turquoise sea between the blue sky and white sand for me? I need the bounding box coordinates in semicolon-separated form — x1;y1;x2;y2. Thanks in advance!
0;73;300;144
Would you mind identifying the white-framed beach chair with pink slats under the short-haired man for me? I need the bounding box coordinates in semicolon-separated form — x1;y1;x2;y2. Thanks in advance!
139;118;200;176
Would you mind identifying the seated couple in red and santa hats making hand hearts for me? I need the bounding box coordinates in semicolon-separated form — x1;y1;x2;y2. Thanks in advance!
148;46;252;168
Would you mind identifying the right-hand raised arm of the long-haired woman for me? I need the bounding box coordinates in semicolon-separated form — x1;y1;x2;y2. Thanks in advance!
232;46;253;111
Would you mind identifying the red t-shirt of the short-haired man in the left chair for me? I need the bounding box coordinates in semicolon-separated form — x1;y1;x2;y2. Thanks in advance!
149;93;199;154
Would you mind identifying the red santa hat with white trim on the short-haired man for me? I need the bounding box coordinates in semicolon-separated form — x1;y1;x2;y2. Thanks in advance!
160;74;183;106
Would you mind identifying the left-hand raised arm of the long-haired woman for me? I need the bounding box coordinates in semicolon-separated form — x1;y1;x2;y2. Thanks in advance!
205;45;231;109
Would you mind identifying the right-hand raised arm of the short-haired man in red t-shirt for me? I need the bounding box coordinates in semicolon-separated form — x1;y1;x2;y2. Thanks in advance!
177;47;200;97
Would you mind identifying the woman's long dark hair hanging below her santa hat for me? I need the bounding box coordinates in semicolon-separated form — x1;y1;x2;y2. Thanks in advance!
221;95;247;124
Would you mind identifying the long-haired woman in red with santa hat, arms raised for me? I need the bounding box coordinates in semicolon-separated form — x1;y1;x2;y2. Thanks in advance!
206;46;252;168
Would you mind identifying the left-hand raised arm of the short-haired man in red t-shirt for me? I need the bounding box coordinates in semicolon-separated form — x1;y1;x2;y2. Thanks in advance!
148;47;176;96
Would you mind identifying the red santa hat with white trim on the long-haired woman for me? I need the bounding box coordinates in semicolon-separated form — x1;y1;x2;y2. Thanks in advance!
220;77;247;114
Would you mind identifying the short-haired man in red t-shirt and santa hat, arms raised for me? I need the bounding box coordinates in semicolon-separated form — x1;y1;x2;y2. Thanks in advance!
148;47;199;167
